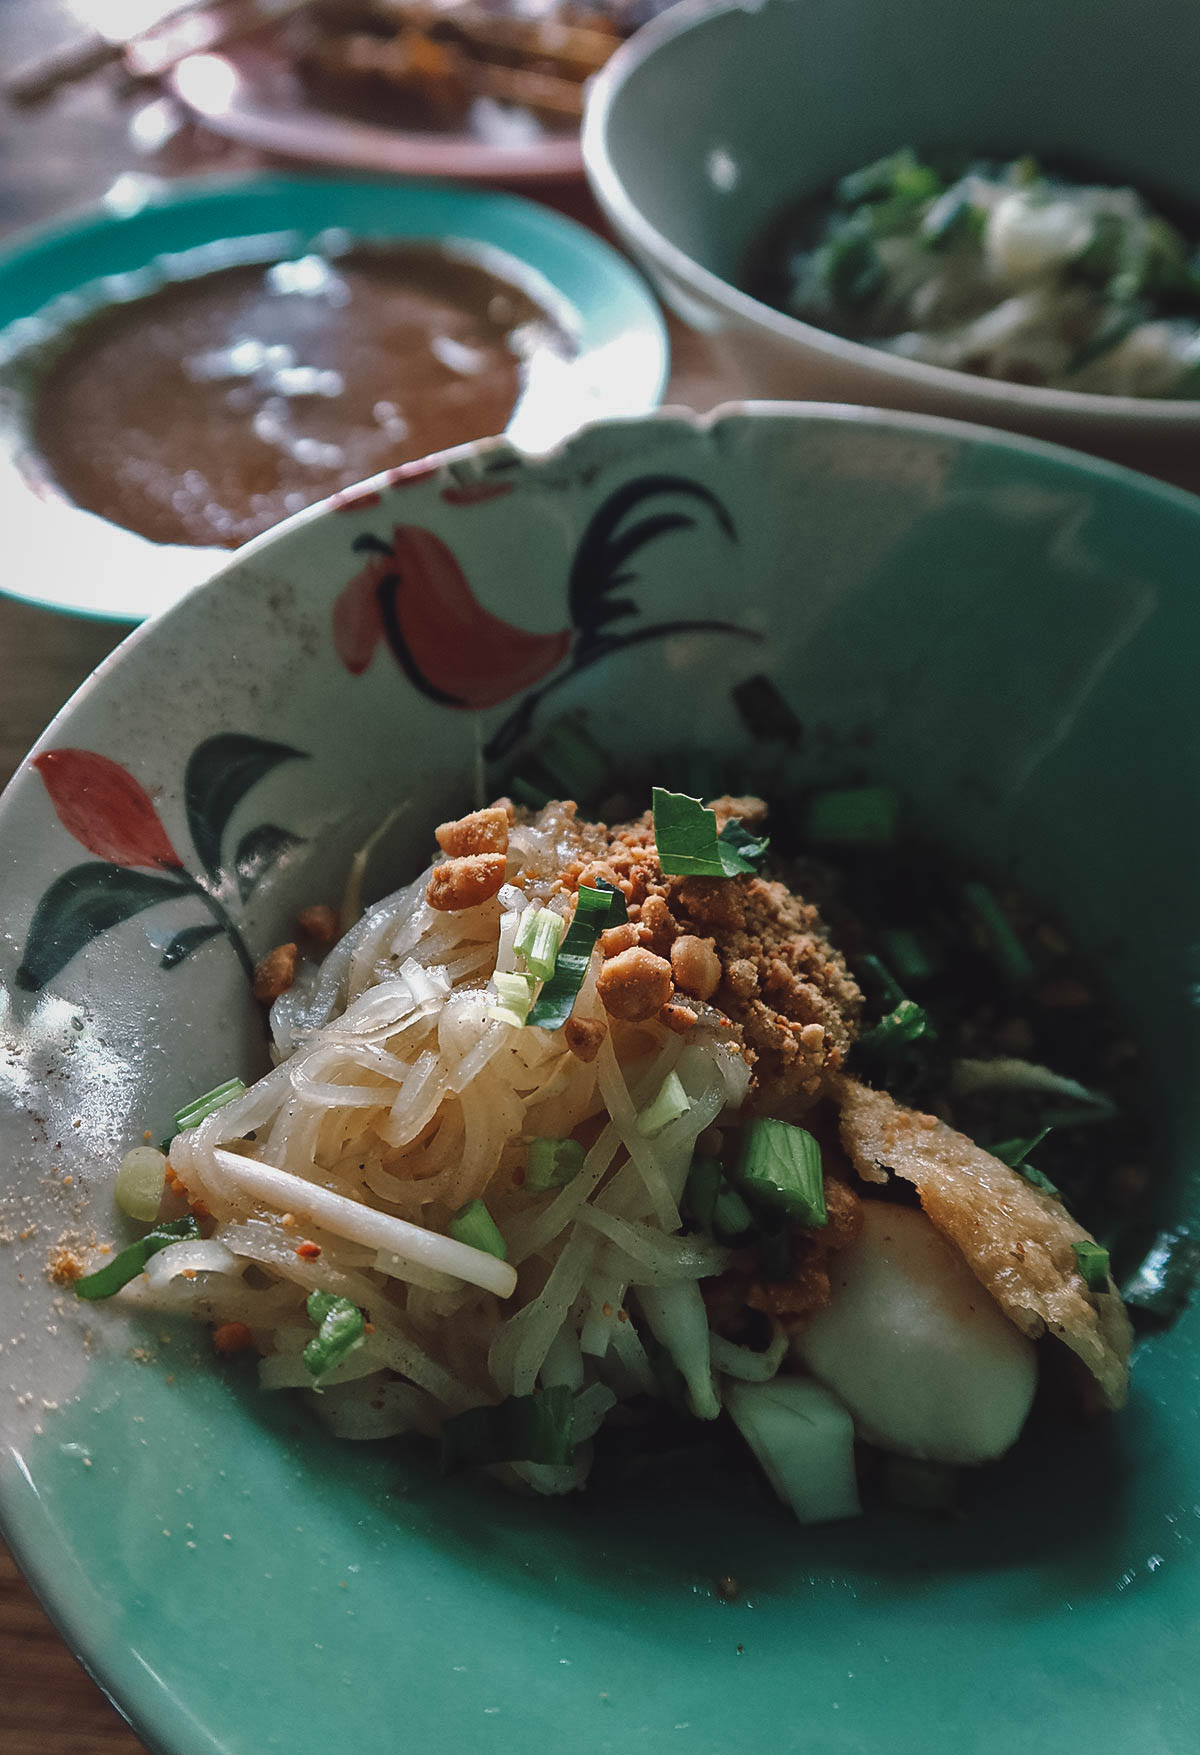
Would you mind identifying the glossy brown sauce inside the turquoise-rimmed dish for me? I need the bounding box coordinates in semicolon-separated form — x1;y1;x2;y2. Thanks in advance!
33;244;570;548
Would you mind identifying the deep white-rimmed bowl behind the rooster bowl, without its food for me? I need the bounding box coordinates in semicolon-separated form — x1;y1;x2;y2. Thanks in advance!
582;0;1200;467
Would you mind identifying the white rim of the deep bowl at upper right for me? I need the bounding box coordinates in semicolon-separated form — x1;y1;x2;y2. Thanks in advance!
581;0;1200;437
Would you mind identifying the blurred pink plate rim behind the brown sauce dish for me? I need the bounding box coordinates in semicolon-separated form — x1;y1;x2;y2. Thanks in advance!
168;40;582;183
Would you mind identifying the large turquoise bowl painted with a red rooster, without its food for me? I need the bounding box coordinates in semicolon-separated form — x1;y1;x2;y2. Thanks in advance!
0;405;1200;1755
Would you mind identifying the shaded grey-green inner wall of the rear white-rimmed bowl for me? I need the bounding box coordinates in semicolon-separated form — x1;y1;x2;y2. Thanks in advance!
605;0;1200;317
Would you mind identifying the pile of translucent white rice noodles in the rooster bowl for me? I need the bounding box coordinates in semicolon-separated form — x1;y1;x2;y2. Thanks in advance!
147;807;749;1492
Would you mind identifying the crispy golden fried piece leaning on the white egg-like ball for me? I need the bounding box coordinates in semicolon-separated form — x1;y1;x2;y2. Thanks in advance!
833;1078;1133;1408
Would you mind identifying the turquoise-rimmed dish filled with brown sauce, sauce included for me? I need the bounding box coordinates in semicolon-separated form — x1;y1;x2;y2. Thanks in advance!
0;177;667;621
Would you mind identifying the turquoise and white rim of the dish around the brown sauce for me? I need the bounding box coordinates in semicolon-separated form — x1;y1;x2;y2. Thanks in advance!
0;177;668;621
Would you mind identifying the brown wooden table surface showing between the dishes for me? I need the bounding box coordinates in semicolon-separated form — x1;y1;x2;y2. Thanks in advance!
0;0;737;1755
